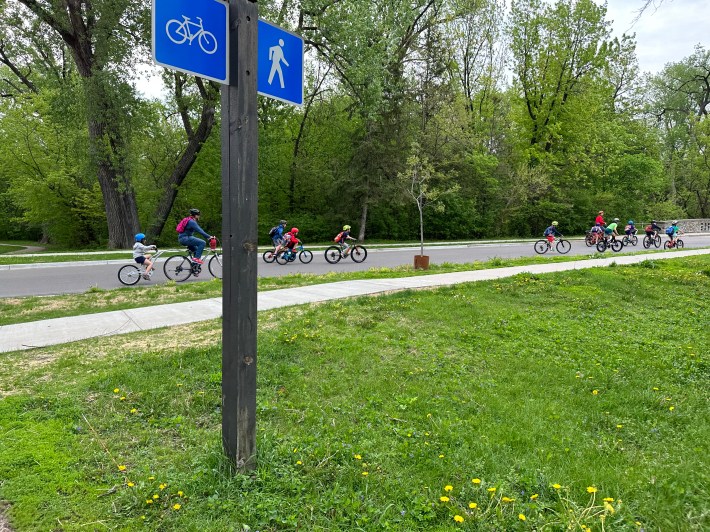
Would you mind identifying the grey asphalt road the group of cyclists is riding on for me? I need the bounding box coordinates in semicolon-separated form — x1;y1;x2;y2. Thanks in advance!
0;235;710;297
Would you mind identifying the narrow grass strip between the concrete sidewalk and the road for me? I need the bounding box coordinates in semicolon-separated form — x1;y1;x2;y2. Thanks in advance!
0;253;684;325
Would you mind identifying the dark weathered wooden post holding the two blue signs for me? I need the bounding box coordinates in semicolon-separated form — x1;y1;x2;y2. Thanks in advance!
222;0;258;470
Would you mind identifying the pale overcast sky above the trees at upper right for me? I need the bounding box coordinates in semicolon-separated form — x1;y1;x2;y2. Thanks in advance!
598;0;710;74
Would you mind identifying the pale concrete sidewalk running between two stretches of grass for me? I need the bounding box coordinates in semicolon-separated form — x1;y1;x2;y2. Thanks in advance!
0;249;710;353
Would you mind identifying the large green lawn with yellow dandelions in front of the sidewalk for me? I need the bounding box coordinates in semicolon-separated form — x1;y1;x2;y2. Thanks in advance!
0;257;710;531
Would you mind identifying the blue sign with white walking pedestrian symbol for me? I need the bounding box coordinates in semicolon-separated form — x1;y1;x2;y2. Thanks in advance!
256;20;303;105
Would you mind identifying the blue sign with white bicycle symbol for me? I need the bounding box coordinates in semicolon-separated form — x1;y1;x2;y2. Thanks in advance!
153;0;229;84
